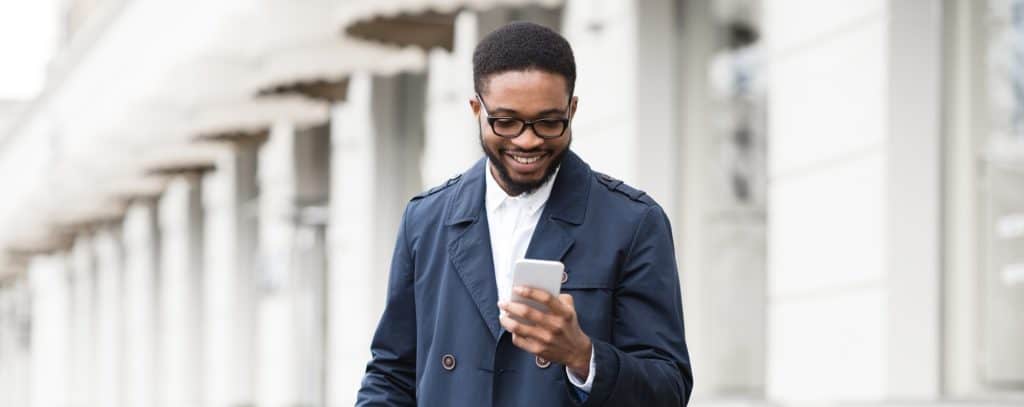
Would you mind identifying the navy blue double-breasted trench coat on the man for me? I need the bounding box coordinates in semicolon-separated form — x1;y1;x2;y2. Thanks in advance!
356;152;693;407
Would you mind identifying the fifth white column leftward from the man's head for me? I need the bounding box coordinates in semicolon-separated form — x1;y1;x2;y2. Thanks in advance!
158;172;206;407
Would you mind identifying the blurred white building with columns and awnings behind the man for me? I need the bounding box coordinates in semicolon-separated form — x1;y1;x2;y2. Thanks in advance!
0;0;1024;407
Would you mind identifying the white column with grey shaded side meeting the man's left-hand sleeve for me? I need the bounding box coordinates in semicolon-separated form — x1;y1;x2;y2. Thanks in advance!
328;74;424;405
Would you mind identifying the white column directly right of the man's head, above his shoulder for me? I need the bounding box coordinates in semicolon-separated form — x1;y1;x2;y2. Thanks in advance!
563;0;679;212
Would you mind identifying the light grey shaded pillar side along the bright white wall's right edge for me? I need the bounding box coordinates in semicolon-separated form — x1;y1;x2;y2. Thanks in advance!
884;0;944;395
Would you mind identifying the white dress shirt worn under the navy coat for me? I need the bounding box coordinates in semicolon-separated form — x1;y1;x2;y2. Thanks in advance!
484;163;595;393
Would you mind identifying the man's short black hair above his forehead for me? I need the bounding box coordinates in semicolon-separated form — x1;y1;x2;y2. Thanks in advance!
473;22;575;94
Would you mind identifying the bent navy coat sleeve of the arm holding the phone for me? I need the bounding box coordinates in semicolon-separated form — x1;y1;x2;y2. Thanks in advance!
582;205;693;407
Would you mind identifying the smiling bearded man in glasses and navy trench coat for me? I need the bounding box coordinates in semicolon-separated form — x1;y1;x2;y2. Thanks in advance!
357;23;692;407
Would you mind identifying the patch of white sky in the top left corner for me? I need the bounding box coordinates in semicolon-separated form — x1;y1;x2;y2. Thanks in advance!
0;0;59;100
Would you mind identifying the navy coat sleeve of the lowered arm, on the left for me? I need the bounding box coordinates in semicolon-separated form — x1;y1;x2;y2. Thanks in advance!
355;203;416;401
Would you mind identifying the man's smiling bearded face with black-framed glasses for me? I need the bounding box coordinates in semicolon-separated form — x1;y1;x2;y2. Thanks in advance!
470;70;577;196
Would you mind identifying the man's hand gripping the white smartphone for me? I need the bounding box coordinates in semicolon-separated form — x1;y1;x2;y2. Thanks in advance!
498;286;593;377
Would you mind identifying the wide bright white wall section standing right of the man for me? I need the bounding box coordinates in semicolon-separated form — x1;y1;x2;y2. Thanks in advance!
764;1;889;401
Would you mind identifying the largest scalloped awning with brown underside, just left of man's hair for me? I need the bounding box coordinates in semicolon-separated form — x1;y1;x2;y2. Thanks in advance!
339;0;564;51
